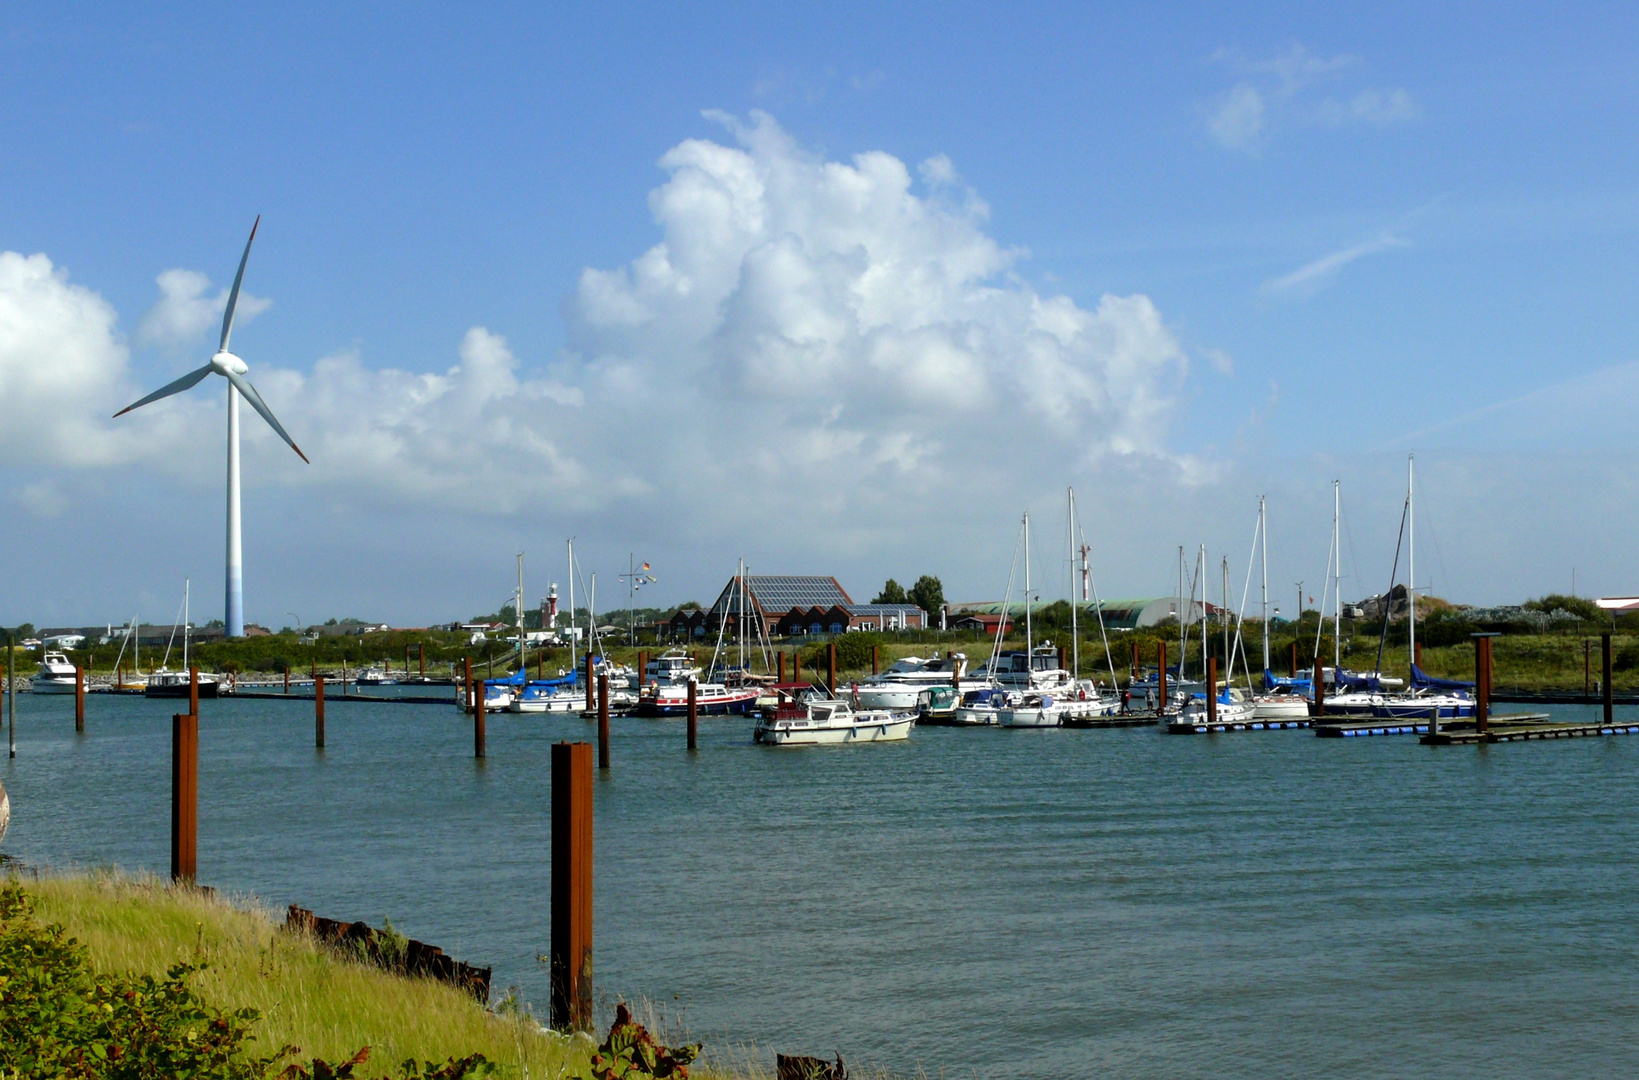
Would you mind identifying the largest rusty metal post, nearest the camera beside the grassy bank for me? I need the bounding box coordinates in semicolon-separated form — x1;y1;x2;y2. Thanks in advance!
551;742;592;1031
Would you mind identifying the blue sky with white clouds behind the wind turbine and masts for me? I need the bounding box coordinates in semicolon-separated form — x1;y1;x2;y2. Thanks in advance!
0;5;1639;624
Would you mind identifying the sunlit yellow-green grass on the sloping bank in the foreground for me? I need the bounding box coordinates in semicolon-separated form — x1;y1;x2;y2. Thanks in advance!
23;874;592;1077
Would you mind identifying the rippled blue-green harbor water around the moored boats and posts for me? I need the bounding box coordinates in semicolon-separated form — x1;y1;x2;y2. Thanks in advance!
0;697;1639;1078
